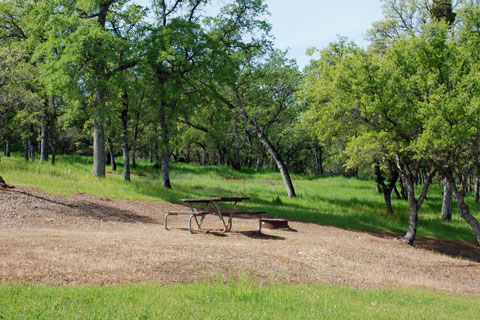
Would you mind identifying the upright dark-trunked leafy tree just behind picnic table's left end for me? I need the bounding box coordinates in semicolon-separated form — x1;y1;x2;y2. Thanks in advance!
146;0;274;188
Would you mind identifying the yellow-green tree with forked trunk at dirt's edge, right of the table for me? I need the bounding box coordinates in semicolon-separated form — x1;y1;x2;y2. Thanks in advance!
303;40;442;244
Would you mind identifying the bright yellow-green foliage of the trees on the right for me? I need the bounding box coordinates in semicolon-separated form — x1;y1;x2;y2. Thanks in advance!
300;9;480;174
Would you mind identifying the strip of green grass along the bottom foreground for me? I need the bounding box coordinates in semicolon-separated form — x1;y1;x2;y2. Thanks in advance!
0;280;480;319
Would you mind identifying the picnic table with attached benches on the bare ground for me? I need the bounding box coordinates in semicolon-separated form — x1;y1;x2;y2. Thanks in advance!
164;197;266;233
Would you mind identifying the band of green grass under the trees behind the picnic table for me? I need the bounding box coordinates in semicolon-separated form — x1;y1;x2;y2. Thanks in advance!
0;154;480;241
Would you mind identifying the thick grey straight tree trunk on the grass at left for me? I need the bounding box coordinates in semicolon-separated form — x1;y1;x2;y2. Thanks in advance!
92;90;106;178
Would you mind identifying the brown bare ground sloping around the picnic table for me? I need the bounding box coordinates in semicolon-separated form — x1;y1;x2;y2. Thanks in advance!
0;187;480;295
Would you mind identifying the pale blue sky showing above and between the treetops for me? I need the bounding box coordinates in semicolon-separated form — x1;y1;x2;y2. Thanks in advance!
135;0;382;68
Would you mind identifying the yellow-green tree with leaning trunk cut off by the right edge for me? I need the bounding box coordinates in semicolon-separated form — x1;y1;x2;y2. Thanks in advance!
418;15;480;244
